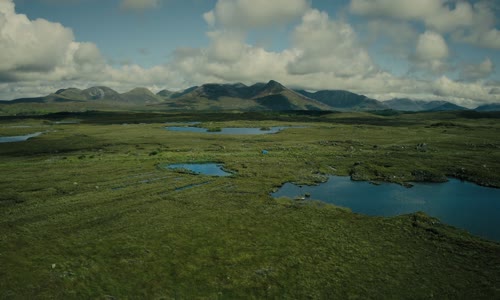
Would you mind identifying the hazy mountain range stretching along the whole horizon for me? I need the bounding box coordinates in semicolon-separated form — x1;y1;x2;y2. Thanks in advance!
0;80;500;111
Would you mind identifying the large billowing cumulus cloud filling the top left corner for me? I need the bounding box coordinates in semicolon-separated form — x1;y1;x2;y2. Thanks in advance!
0;1;110;81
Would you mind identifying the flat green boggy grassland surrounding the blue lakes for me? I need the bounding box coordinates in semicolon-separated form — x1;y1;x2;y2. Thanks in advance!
0;111;500;299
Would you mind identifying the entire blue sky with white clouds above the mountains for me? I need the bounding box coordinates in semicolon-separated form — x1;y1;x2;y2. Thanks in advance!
0;0;500;108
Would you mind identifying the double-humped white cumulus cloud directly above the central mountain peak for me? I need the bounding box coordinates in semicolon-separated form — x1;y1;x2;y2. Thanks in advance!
175;9;377;84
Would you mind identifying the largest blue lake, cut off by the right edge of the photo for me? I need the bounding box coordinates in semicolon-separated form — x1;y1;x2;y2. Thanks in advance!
272;176;500;241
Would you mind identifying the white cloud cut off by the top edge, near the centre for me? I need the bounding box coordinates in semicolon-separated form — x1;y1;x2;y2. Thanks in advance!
204;0;309;29
